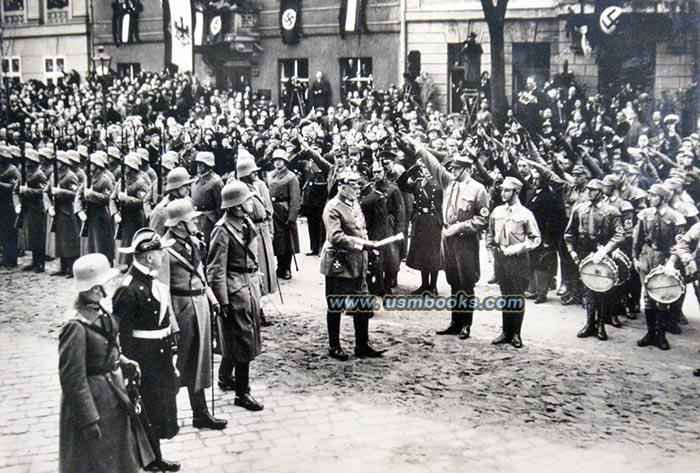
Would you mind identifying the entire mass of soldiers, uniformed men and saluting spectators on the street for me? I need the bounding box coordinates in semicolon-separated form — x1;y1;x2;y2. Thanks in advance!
0;67;700;472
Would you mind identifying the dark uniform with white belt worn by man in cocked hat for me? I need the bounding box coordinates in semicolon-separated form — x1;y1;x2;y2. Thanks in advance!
112;263;179;439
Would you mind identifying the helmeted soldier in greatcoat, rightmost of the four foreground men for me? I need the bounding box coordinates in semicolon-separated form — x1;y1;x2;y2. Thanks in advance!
207;181;263;411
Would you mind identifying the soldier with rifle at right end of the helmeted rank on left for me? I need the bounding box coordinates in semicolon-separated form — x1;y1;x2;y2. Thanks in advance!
113;153;150;264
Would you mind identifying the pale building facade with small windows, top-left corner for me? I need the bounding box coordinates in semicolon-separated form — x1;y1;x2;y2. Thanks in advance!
0;0;89;84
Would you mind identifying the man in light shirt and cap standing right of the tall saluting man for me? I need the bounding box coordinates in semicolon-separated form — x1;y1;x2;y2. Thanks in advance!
486;176;542;348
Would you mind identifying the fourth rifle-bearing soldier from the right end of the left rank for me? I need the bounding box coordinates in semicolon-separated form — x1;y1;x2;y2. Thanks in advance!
19;149;48;273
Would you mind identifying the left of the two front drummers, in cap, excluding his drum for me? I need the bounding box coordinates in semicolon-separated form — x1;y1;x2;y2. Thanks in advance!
564;179;624;340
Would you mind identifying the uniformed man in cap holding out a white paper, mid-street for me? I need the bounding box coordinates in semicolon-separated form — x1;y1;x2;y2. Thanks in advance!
321;171;384;361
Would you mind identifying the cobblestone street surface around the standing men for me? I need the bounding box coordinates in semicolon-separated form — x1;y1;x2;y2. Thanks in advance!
0;222;700;472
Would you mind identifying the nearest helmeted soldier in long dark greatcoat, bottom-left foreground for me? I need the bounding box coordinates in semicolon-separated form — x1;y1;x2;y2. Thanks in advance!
58;254;155;473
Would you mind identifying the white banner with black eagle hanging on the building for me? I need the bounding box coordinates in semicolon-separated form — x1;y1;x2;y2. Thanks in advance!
166;0;194;72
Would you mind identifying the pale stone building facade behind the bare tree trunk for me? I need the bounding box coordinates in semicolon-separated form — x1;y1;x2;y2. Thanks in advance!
405;0;698;111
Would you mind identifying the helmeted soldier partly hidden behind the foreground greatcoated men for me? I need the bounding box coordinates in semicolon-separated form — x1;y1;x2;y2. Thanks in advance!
192;151;224;243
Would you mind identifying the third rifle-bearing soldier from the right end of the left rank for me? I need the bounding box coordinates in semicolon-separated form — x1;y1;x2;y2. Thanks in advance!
49;151;80;278
